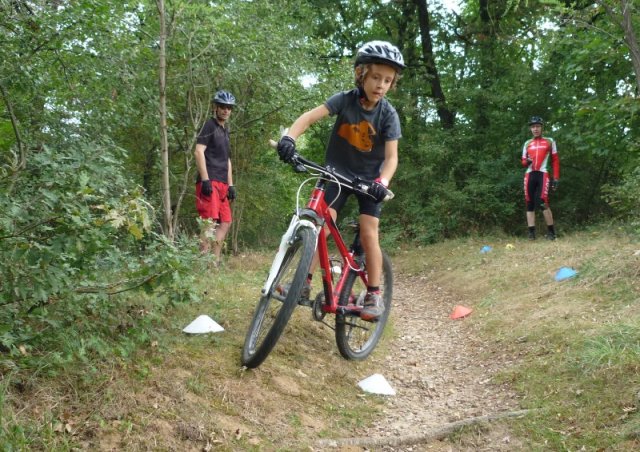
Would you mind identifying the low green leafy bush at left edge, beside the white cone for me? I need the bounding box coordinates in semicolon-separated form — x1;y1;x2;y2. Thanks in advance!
0;143;197;361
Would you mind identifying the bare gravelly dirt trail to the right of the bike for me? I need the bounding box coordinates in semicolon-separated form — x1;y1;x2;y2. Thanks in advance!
330;275;519;451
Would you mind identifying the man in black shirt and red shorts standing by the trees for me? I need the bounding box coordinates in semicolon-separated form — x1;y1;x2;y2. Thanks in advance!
195;91;236;265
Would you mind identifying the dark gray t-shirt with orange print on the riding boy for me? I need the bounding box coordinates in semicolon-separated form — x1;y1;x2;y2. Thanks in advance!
325;89;402;180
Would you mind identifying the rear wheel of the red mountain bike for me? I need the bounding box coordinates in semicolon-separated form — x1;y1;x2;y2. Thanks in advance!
336;251;393;361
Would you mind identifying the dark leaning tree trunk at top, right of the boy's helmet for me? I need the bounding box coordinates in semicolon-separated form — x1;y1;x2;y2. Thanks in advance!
415;0;455;129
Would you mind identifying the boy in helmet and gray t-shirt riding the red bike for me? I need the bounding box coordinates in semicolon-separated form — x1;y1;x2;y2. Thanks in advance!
278;41;405;321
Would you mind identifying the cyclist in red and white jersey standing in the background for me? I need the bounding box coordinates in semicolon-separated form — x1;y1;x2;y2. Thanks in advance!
522;116;560;240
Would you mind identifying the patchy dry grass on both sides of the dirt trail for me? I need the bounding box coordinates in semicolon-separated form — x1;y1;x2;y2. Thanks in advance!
0;226;640;451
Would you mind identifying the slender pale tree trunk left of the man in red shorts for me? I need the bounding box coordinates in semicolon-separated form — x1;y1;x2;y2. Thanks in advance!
156;0;174;241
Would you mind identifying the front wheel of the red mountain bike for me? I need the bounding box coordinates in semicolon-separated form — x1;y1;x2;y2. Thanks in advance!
242;228;315;368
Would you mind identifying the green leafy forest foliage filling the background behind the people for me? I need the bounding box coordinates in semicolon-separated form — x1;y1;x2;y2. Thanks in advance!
0;0;640;392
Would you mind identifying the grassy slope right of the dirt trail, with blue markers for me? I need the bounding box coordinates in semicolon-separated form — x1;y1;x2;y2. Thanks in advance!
390;230;640;450
